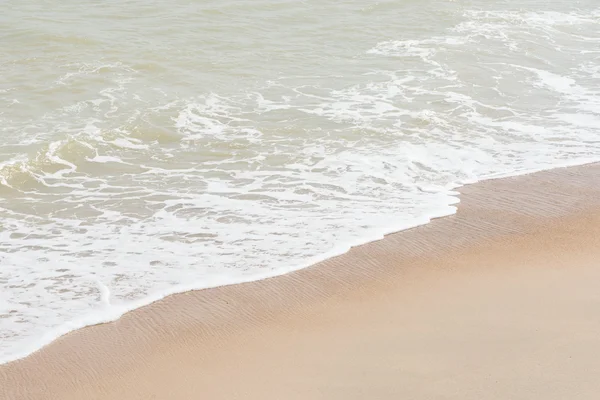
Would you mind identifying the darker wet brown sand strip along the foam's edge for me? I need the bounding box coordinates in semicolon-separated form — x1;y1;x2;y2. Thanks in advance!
0;164;600;399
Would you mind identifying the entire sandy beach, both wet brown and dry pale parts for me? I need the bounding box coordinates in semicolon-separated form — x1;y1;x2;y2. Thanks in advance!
0;164;600;400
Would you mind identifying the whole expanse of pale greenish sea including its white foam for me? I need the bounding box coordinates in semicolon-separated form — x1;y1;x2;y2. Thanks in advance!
0;0;600;362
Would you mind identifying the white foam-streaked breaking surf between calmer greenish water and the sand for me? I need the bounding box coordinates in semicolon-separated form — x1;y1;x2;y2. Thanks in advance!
0;3;600;362
